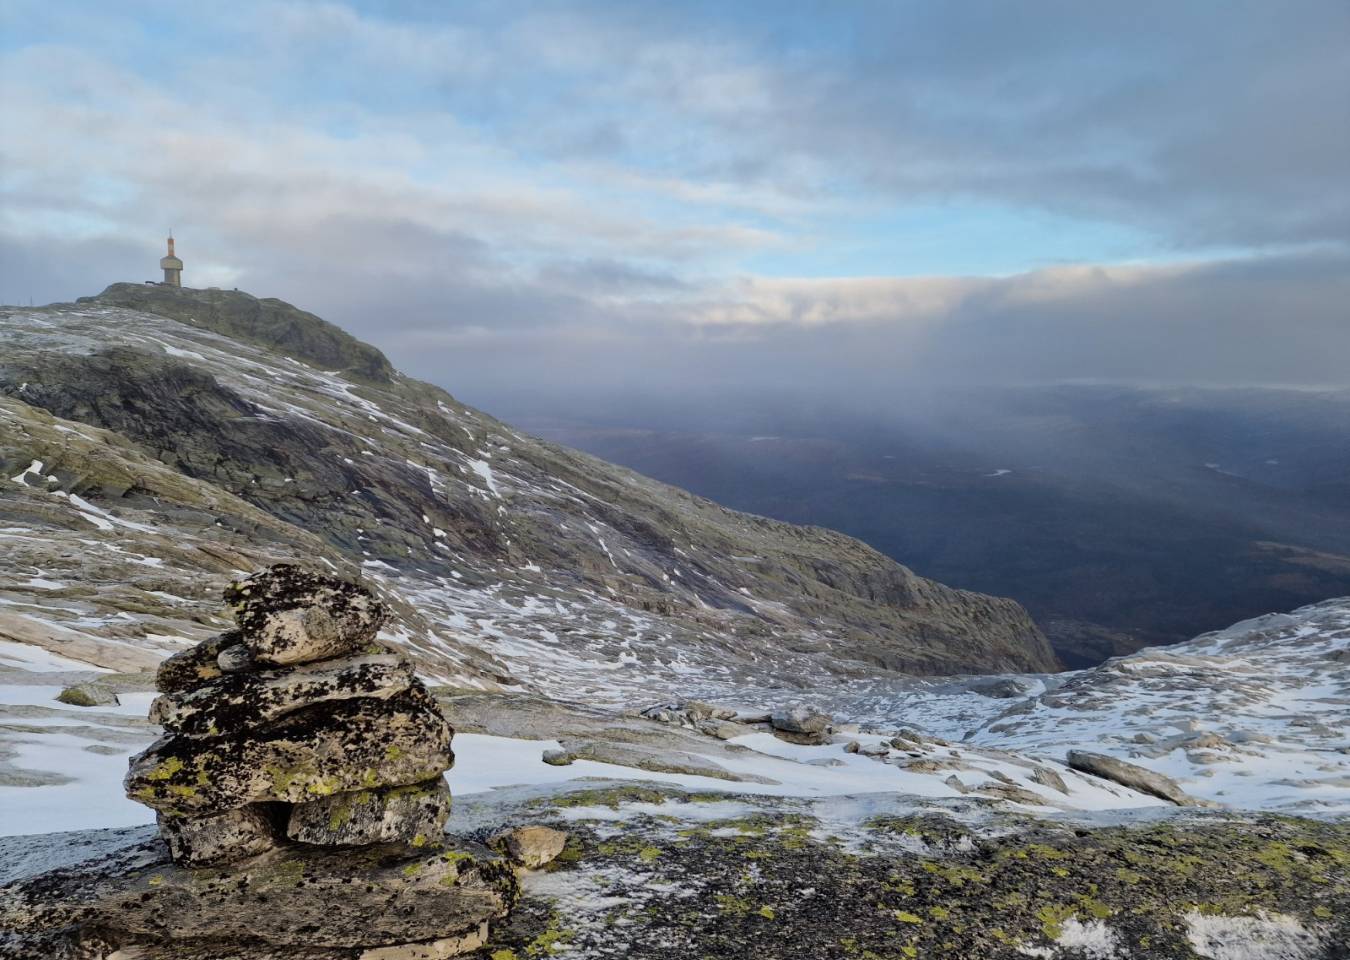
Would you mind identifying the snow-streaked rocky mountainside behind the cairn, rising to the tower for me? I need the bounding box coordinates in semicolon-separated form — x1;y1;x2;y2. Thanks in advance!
0;284;1054;698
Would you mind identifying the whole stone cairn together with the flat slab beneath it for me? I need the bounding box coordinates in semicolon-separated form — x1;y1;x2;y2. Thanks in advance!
97;564;517;960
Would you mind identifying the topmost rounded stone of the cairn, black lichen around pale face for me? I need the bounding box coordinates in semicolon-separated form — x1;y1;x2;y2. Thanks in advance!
225;563;389;666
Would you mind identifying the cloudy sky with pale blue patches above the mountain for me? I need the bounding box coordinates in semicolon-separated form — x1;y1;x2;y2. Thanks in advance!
0;0;1350;409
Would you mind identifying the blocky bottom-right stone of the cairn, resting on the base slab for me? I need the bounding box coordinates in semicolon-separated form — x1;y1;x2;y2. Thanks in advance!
286;776;450;847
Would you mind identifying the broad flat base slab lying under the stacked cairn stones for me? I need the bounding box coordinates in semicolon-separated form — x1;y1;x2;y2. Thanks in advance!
0;841;518;956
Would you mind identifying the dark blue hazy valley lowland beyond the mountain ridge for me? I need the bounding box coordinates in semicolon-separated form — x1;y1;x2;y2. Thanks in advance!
509;386;1350;667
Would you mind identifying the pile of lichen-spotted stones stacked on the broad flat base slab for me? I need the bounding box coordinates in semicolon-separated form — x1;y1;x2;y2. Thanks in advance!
126;564;454;865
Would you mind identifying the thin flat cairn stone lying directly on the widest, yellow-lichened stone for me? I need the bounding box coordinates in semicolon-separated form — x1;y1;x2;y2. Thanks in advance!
150;656;413;736
